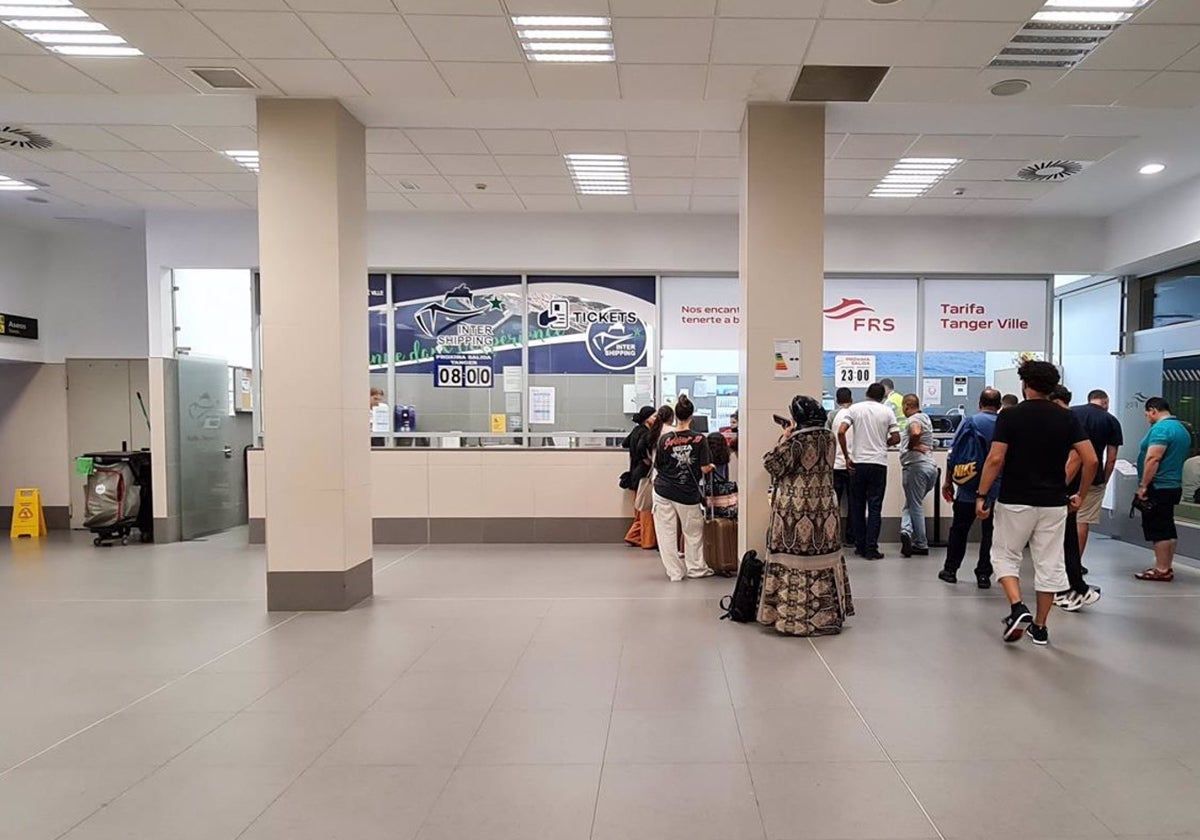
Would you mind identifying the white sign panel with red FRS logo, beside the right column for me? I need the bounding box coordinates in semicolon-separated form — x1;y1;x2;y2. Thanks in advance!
824;278;917;353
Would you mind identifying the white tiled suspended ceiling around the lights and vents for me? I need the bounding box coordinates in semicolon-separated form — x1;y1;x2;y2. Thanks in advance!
0;0;1200;216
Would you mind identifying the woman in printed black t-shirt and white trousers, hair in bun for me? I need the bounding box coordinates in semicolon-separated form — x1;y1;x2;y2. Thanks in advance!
654;395;713;581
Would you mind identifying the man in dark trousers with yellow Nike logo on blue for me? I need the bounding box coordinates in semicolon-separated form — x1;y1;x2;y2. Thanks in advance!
937;388;1002;589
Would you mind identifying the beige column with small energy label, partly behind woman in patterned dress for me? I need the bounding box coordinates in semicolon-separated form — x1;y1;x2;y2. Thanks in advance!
738;104;824;554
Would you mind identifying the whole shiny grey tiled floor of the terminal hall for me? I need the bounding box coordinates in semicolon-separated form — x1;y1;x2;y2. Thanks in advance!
0;533;1200;840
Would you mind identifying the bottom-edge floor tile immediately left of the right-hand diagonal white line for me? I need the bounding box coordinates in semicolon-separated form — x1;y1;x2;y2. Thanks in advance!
750;762;937;840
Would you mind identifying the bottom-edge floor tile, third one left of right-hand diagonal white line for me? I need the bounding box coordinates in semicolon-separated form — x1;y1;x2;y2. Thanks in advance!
418;766;600;840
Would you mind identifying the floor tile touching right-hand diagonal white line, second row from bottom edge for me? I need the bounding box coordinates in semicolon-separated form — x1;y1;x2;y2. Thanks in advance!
737;707;887;763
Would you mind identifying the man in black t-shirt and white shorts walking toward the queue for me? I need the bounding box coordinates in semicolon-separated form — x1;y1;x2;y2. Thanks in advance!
976;361;1097;644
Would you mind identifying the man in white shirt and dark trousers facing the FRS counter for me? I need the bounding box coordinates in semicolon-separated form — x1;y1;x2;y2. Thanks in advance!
838;383;900;560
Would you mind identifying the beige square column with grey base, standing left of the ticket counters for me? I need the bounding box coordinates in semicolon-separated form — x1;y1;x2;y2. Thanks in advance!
258;100;373;610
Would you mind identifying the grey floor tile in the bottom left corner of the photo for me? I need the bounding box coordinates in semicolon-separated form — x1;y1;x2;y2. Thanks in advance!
0;767;154;840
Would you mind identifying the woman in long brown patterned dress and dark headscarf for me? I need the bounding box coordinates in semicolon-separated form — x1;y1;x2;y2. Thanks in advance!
758;396;854;636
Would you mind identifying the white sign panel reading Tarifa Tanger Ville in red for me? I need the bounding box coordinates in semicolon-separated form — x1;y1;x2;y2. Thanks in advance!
924;280;1049;350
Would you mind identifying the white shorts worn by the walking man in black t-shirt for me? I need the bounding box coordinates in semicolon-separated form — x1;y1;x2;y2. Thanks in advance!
991;504;1070;592
